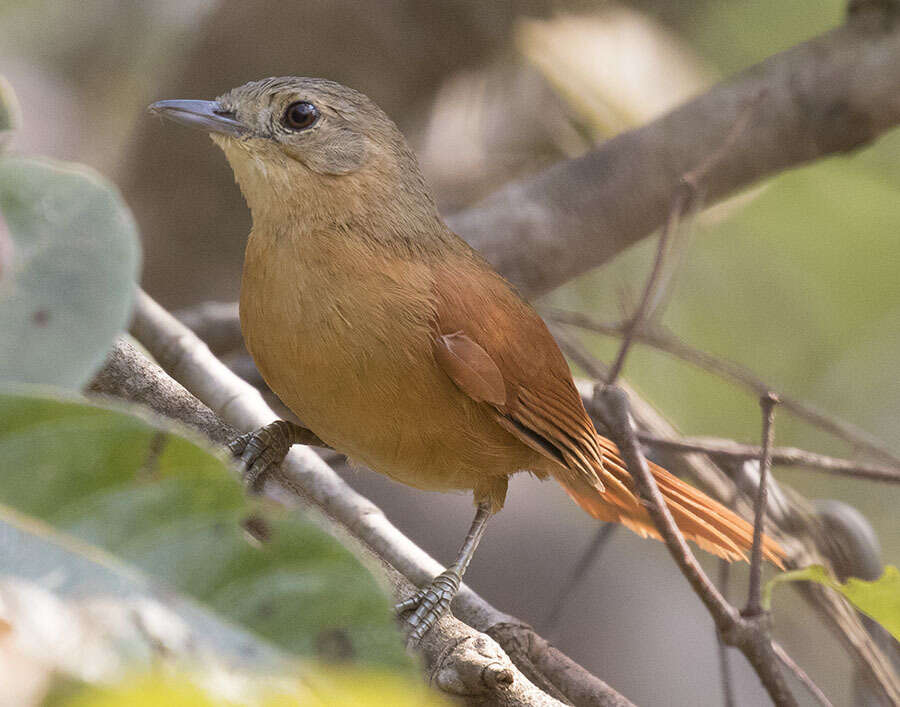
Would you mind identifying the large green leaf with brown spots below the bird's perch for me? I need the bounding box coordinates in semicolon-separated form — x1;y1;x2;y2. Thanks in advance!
0;393;411;668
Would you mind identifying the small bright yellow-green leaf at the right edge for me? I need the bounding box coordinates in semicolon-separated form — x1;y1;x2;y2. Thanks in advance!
763;565;900;641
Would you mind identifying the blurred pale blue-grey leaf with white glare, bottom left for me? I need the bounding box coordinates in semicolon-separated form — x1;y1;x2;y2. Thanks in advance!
0;505;289;673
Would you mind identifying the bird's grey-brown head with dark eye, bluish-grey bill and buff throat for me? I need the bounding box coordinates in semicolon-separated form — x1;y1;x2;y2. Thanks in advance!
149;77;436;231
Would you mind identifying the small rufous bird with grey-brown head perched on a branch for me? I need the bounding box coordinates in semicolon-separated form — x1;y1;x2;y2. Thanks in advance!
150;77;784;641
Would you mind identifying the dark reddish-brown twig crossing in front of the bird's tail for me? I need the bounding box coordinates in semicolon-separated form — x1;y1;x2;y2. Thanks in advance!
596;386;797;707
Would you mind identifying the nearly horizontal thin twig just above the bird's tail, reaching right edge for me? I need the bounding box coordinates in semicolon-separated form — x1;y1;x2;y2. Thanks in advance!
638;432;900;484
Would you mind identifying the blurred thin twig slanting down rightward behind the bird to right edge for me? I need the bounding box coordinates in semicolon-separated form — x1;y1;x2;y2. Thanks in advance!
541;308;900;466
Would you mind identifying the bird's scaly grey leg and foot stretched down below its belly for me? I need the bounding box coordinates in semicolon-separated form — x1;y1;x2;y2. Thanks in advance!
395;503;491;644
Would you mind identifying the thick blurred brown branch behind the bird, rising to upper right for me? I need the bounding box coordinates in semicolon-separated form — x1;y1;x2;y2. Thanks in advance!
448;12;900;297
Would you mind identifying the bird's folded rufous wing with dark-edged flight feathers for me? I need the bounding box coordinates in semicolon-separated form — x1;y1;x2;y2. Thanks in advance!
434;261;604;490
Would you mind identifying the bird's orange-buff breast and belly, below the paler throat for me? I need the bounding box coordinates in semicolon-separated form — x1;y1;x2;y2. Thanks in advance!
241;228;535;498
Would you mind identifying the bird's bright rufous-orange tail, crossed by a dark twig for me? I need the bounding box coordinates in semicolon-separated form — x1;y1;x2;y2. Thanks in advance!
554;435;784;569
